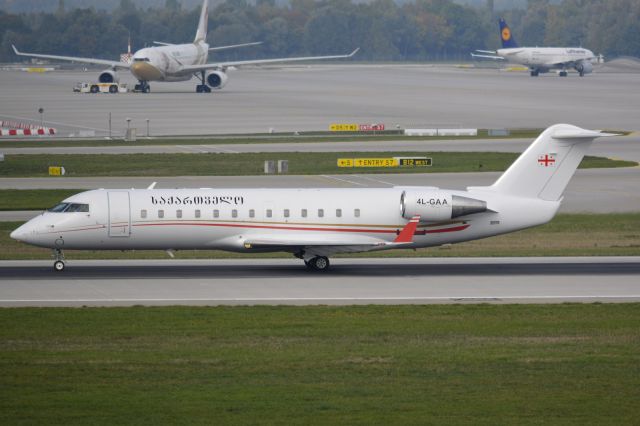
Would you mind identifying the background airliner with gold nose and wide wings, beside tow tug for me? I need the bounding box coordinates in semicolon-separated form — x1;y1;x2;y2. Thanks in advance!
12;0;358;93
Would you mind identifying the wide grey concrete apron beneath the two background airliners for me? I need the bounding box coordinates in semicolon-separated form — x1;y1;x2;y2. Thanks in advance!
0;63;640;136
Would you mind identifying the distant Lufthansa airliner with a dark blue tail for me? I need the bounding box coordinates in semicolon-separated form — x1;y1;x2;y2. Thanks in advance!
471;19;595;77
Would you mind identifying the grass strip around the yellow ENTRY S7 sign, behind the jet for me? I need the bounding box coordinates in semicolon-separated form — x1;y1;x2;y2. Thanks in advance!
0;152;637;177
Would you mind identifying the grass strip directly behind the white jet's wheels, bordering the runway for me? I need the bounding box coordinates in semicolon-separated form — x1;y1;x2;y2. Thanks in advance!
5;213;640;260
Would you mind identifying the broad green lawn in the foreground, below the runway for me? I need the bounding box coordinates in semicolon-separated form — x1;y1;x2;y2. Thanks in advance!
0;304;640;426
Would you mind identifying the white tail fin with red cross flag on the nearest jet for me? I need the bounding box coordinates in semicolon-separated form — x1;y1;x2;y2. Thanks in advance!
488;124;618;201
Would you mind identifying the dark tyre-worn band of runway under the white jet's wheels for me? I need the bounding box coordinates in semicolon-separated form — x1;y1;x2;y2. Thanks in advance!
0;262;640;280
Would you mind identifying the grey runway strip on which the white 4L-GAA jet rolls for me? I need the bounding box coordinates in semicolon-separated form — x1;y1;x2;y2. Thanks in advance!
0;257;640;306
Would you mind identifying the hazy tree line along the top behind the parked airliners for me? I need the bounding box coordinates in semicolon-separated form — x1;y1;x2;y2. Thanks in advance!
0;0;640;62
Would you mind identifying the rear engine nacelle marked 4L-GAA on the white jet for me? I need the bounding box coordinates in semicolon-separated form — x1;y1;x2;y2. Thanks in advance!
400;190;487;222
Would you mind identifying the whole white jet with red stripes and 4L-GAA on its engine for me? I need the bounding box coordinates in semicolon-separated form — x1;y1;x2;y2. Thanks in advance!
11;124;613;271
